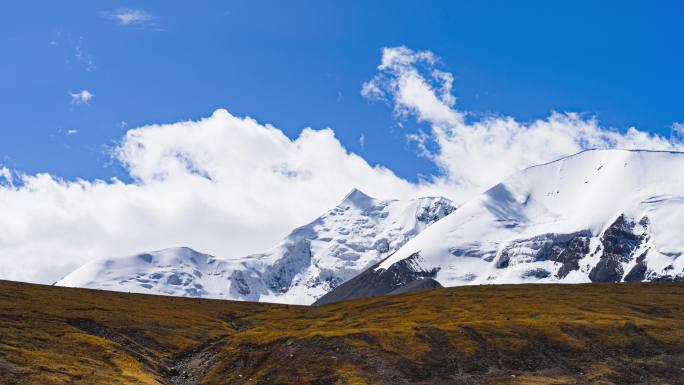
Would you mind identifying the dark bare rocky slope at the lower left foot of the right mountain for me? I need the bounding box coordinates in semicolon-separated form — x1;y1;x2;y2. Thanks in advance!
314;253;438;305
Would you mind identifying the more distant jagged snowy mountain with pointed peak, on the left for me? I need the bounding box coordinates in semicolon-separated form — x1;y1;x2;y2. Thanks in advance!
56;189;455;304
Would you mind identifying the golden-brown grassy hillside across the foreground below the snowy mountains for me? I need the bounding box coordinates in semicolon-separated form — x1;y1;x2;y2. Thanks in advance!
0;281;684;384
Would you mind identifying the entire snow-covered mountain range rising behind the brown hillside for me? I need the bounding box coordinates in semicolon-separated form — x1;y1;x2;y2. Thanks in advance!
57;150;684;304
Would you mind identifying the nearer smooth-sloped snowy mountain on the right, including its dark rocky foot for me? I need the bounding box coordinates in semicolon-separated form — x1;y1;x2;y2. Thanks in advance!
318;150;684;304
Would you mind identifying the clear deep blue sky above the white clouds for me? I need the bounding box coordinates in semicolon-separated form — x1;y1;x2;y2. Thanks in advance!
0;1;684;181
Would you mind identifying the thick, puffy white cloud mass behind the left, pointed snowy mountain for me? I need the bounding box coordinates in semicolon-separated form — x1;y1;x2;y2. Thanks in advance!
0;110;428;283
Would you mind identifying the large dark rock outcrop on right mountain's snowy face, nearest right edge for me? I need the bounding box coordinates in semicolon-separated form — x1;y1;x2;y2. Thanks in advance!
589;215;648;282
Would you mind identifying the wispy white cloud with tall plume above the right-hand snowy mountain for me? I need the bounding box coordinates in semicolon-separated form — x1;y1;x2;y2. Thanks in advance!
361;46;683;200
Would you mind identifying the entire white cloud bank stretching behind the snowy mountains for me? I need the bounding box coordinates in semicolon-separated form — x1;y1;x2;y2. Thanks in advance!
0;47;679;283
